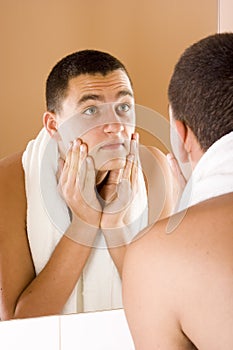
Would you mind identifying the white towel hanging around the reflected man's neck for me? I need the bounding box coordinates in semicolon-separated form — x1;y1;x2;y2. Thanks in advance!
23;129;148;314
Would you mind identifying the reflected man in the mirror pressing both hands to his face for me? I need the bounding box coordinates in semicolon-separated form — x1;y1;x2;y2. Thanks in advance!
0;50;173;320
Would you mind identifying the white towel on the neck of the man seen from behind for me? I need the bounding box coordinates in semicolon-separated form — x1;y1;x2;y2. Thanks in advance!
177;132;233;211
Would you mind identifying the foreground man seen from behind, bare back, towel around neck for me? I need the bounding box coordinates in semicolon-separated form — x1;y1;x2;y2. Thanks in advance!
123;33;233;350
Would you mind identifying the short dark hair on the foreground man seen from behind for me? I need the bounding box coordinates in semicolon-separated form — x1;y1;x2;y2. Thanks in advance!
168;33;233;151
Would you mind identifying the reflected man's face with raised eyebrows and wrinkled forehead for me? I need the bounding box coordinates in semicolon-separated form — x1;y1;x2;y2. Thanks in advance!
52;69;135;170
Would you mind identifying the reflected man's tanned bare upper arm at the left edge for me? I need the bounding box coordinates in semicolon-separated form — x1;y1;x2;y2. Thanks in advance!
0;152;35;320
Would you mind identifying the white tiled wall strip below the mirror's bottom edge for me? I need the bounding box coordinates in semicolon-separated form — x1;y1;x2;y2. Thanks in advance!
0;309;134;350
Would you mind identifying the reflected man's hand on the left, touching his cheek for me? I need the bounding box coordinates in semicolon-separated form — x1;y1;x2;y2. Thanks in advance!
58;139;102;245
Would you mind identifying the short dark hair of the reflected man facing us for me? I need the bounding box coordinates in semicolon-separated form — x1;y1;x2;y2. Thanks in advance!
46;50;132;113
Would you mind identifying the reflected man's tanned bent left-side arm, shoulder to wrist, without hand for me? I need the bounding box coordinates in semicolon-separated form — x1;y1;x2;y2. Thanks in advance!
0;154;96;320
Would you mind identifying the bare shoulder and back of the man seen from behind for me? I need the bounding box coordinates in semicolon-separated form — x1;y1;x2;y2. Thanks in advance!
123;193;233;350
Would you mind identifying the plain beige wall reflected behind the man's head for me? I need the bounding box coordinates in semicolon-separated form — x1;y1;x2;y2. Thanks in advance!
0;0;218;157
